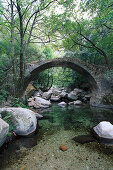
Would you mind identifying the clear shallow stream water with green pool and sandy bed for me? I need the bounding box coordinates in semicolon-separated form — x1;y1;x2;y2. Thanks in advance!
0;104;113;170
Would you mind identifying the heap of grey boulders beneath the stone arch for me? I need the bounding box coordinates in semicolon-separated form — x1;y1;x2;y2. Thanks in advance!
28;88;91;108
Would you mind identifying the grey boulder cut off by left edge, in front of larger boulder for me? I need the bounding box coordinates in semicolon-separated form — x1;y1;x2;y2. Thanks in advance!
0;118;9;147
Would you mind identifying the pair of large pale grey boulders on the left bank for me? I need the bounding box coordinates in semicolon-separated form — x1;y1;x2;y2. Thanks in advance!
0;107;43;147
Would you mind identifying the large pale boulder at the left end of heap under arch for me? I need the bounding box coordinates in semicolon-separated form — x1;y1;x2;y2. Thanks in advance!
28;97;51;108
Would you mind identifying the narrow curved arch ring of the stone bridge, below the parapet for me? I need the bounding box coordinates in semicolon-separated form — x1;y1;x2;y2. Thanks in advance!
24;58;98;92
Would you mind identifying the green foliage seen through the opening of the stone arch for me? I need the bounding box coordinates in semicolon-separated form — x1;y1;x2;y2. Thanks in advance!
33;67;90;91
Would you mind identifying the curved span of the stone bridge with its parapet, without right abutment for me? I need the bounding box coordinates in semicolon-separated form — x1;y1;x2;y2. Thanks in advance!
24;57;99;93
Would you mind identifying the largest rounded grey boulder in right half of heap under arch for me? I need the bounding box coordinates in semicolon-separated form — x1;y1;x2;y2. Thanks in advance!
68;88;83;100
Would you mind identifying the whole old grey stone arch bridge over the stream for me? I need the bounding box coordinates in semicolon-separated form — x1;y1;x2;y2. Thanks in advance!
23;57;111;104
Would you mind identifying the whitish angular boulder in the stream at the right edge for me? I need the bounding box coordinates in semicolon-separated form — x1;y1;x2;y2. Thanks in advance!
93;121;113;139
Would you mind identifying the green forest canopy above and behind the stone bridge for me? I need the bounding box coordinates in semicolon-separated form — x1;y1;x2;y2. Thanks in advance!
0;0;113;101
